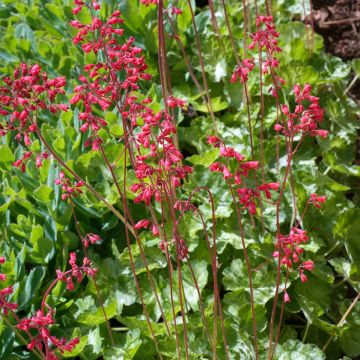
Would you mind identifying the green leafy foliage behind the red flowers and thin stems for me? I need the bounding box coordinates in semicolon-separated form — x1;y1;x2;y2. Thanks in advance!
0;0;360;360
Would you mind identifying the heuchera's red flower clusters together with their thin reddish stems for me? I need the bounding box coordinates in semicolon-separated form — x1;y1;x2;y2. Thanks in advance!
0;0;338;359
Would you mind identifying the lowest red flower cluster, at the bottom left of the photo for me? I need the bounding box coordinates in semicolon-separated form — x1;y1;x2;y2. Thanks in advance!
16;308;79;360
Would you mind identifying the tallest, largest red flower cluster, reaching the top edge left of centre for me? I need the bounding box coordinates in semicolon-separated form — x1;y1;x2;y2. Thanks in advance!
70;1;151;150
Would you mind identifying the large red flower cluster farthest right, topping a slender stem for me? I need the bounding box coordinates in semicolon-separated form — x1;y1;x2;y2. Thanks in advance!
274;84;328;138
